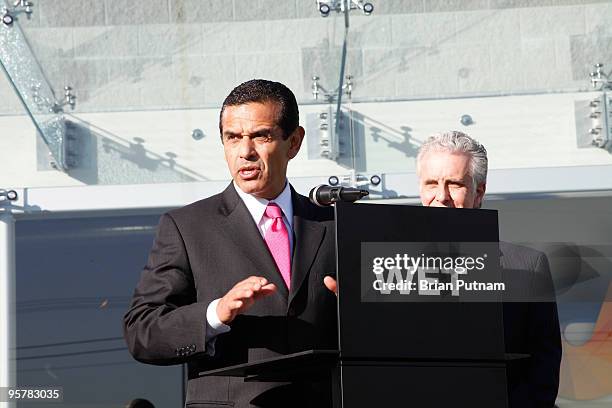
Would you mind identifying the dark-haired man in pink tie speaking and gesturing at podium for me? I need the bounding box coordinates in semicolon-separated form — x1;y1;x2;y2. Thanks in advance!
124;80;338;408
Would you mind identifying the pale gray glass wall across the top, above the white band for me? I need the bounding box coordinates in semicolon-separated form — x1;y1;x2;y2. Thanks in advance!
3;0;612;112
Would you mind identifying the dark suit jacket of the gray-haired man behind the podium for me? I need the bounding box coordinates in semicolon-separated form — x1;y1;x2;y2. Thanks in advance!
500;242;561;408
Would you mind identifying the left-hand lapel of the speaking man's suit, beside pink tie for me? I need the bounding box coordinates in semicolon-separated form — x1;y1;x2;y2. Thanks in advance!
221;184;288;299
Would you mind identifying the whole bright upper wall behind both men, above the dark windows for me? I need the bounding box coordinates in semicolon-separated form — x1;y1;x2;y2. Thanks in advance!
0;0;612;187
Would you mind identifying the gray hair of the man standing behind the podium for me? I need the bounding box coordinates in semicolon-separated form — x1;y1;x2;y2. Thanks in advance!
416;130;488;189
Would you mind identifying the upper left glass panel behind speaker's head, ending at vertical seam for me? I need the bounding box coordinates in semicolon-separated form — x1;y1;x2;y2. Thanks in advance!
1;0;358;186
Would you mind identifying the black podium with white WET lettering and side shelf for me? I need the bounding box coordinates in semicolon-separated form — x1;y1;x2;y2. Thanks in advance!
201;203;526;408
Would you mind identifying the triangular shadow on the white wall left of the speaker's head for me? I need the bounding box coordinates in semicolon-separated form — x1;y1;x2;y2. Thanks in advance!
39;120;207;185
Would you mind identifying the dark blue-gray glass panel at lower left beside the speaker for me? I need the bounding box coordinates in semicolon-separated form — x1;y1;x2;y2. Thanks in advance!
16;215;183;407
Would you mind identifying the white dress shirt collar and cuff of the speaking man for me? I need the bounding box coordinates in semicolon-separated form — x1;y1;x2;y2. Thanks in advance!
205;182;293;356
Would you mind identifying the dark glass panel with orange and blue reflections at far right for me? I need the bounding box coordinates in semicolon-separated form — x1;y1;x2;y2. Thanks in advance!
487;197;612;408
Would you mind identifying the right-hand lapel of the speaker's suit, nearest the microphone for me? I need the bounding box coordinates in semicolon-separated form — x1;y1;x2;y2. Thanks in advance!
289;188;325;304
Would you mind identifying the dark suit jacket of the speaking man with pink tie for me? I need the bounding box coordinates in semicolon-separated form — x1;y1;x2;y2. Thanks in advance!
124;185;338;408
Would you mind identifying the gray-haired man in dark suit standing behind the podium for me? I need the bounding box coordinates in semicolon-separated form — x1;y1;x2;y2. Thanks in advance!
417;131;561;408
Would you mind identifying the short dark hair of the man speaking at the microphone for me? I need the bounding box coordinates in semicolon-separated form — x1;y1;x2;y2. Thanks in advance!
219;79;300;139
